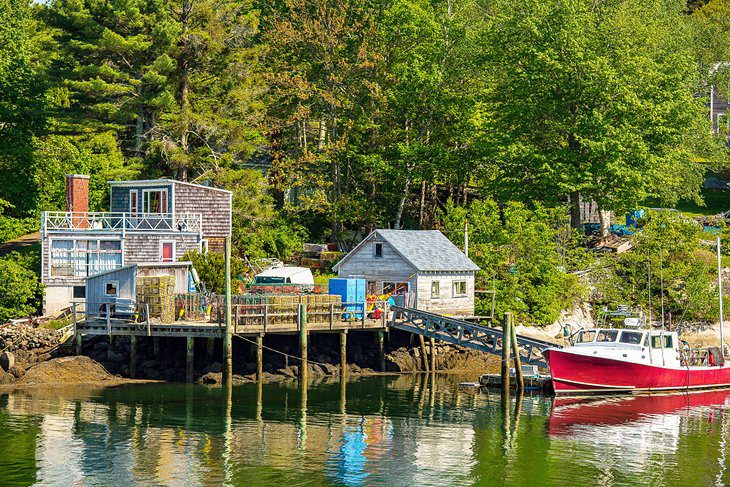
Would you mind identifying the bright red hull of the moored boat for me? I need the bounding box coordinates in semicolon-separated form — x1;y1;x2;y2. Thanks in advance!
543;348;730;395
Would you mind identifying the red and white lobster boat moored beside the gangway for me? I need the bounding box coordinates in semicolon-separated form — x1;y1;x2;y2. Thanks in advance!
543;328;730;395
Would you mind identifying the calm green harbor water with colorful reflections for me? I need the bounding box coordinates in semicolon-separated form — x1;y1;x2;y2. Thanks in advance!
0;376;730;487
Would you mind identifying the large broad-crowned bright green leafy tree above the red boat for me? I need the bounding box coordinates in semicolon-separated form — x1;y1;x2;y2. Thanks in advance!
484;0;720;231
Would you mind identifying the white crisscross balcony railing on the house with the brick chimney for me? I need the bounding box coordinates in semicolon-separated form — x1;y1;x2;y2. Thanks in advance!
41;211;203;233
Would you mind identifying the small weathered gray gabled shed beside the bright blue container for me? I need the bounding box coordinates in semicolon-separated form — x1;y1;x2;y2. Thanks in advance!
334;230;479;316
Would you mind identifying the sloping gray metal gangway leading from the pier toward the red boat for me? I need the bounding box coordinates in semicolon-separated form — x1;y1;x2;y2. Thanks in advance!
390;306;560;367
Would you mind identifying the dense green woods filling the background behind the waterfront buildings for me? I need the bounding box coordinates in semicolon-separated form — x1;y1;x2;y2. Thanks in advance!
0;0;730;323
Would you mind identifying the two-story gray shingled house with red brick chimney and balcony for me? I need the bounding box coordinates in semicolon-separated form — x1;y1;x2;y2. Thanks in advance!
41;174;232;314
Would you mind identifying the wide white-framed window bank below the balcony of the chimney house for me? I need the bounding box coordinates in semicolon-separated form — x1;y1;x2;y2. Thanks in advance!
50;239;122;277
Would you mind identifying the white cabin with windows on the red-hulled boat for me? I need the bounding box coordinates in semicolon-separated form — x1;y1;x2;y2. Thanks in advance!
573;328;680;367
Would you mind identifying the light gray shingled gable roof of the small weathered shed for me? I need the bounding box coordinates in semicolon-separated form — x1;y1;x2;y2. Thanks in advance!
335;230;479;272
